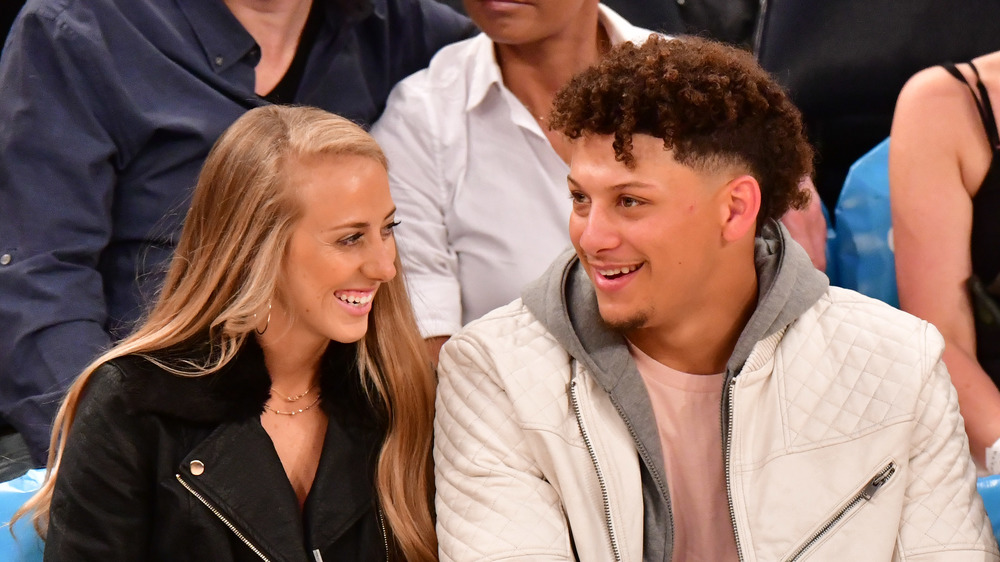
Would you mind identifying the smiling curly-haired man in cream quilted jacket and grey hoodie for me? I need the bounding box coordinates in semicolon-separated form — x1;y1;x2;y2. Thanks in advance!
435;37;997;562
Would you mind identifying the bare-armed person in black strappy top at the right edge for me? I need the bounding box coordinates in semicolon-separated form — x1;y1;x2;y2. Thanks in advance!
889;52;1000;473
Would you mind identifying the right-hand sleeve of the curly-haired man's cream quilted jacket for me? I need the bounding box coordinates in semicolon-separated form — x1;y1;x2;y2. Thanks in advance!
895;325;998;561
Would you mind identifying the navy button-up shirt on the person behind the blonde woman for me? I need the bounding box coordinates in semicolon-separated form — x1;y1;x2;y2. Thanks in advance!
0;0;474;466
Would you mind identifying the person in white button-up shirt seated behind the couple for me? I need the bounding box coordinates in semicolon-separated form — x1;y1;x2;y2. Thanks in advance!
372;0;650;358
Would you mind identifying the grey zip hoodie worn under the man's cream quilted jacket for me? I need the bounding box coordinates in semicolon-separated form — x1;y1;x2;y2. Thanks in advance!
522;221;829;562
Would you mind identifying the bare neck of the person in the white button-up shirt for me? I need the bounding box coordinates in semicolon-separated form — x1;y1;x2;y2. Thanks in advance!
496;5;609;122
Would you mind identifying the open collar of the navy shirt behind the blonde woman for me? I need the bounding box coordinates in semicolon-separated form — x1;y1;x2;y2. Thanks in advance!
177;0;387;73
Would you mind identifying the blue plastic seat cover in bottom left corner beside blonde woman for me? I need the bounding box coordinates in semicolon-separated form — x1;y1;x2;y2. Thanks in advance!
0;468;45;562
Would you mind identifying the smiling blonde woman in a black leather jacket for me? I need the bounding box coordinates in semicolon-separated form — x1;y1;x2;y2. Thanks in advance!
16;107;436;561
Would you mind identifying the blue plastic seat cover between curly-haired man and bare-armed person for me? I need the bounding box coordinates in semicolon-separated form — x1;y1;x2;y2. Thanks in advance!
830;139;899;307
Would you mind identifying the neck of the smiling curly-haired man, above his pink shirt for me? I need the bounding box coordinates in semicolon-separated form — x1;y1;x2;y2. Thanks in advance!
626;260;758;375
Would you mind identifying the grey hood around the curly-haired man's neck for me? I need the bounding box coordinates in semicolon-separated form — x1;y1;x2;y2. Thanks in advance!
522;217;830;382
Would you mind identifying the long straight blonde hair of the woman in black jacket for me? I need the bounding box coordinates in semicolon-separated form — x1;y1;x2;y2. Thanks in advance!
17;106;437;560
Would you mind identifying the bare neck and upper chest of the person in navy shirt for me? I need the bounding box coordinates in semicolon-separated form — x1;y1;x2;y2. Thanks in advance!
224;0;312;95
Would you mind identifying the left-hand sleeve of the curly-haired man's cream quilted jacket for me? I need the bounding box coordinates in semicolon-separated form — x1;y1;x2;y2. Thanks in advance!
434;335;573;561
